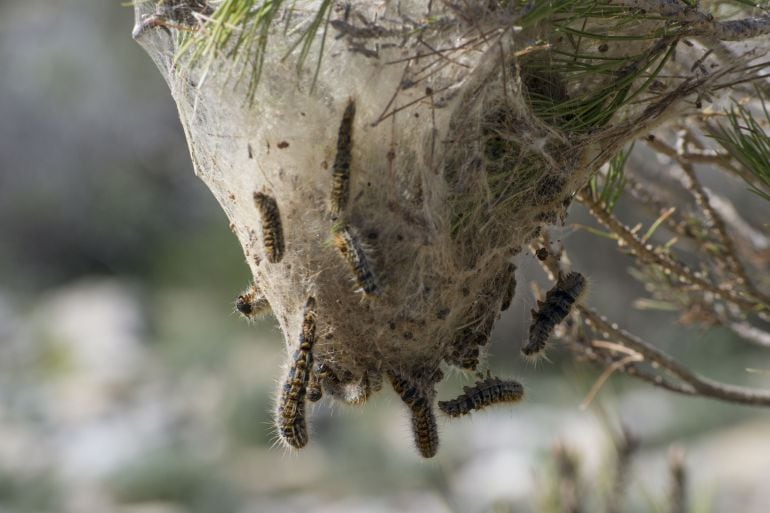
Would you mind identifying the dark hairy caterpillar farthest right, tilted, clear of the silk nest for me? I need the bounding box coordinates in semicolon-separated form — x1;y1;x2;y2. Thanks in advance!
521;272;586;356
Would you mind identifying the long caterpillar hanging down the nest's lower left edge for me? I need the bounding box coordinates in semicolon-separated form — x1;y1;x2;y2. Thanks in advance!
275;297;316;449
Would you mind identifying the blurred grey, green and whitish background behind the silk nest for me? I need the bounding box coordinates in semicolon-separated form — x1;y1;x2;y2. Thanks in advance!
0;0;770;513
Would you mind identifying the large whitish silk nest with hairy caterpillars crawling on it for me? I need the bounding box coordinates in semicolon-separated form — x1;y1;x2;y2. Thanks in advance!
134;0;718;457
